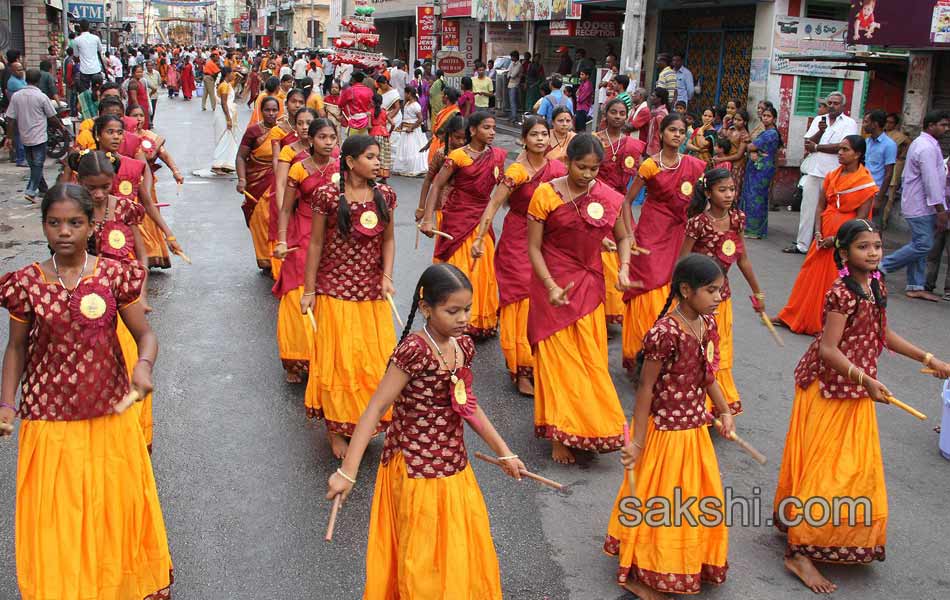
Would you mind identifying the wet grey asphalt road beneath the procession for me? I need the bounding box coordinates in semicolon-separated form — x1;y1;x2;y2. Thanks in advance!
0;99;950;600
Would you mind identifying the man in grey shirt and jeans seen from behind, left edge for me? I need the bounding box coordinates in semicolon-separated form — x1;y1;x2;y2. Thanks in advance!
6;63;62;202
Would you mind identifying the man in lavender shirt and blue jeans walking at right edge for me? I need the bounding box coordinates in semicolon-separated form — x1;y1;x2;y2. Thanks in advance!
880;109;950;302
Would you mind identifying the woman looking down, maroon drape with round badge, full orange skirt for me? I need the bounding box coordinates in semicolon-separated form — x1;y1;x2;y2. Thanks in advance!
528;133;630;464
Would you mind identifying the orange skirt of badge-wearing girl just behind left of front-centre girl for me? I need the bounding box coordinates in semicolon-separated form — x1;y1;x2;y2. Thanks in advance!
298;294;396;435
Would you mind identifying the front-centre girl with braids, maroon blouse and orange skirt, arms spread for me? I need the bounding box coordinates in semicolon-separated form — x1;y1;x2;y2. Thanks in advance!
327;263;524;600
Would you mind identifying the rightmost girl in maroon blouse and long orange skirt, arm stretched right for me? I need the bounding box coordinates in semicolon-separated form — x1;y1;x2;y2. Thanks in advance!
774;219;950;594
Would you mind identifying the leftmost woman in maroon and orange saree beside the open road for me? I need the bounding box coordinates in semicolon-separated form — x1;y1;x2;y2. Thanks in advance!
237;96;280;271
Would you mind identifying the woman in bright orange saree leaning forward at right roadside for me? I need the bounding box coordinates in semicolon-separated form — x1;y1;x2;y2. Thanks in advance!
772;135;878;335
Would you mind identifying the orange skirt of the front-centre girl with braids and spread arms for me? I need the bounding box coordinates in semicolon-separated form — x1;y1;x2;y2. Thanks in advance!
363;451;502;600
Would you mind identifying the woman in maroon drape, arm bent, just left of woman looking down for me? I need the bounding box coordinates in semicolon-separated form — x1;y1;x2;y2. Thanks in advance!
472;115;567;396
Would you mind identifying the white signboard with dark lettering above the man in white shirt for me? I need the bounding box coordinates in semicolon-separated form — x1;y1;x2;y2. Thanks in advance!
771;16;861;79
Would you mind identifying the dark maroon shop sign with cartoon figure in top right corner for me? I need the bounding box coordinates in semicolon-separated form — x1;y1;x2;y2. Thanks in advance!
848;0;950;48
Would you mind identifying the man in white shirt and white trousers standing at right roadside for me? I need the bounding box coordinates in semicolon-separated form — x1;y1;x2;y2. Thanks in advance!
782;92;858;254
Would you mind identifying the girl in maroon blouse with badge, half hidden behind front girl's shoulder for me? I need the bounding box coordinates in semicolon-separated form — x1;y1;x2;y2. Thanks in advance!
680;169;765;415
